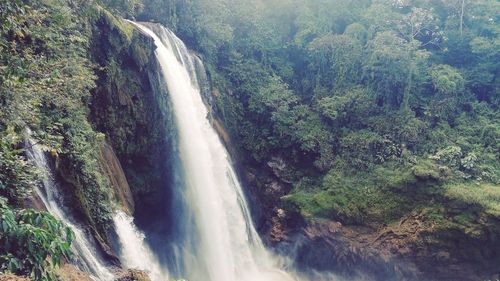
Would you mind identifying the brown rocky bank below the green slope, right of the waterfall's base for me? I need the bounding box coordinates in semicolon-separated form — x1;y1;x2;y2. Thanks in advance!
276;214;500;281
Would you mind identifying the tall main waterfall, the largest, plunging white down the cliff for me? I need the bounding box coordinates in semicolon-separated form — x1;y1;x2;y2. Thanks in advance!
130;23;298;281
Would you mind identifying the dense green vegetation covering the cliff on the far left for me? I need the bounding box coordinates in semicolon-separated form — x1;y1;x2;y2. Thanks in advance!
0;0;123;280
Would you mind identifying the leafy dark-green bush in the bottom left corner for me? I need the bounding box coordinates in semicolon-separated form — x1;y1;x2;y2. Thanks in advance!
0;197;74;280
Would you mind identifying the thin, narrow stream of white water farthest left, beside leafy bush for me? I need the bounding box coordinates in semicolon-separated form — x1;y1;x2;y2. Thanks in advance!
26;135;114;281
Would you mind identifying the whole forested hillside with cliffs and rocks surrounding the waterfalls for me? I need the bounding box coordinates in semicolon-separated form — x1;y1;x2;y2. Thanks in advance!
0;0;500;280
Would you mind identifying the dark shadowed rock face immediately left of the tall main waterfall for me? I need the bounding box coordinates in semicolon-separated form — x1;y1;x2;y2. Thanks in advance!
89;12;173;228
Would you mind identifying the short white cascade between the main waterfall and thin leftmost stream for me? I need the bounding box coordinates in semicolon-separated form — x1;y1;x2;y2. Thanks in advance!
113;211;170;281
